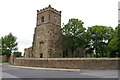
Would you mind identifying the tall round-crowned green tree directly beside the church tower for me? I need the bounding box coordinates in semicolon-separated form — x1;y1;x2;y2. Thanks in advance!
62;18;86;57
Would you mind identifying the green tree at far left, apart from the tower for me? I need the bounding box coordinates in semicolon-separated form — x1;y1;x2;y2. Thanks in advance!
1;33;18;55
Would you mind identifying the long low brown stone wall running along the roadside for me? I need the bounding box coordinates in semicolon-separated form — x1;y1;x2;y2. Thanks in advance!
14;58;120;70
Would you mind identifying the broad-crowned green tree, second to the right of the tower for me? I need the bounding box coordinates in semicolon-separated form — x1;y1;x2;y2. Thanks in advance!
87;25;114;57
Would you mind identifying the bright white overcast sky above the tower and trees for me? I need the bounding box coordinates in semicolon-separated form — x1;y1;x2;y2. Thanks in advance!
0;0;120;52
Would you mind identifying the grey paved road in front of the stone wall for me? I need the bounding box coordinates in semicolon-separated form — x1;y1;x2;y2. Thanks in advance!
0;63;118;80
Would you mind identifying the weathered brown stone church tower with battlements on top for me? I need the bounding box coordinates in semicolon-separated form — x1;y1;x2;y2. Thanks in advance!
29;5;63;58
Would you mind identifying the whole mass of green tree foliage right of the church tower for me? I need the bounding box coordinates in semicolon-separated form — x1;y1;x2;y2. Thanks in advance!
62;18;120;57
